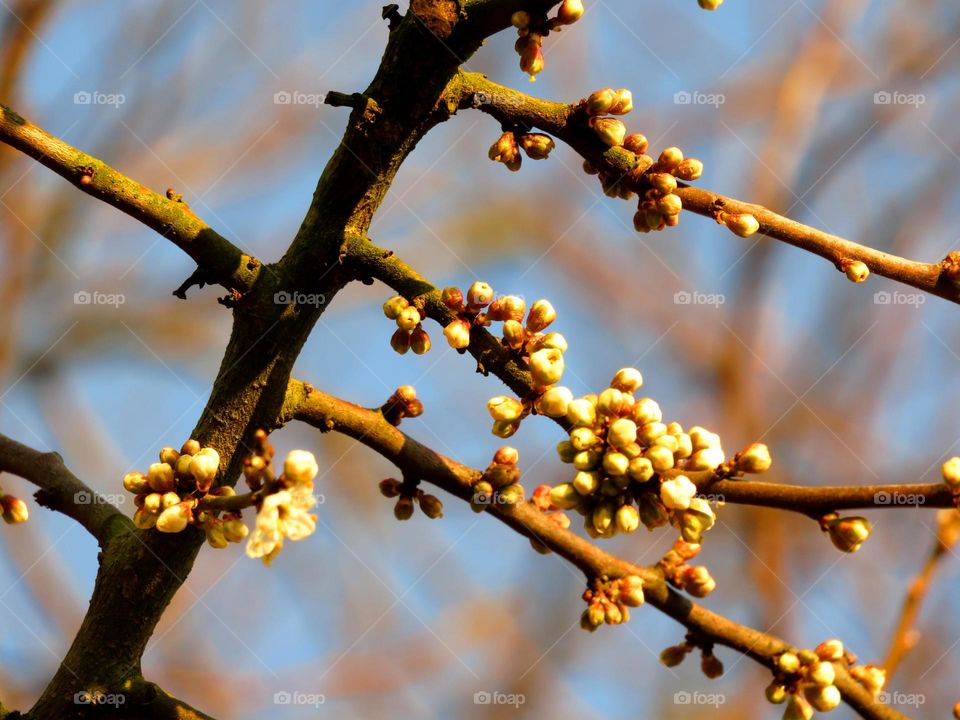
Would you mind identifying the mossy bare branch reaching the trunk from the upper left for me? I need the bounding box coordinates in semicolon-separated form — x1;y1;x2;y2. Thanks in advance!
0;105;260;292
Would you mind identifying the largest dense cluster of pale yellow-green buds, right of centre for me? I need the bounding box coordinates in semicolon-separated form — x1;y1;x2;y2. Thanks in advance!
548;368;771;544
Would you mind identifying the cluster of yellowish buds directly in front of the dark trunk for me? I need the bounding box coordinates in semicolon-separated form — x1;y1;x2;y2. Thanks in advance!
123;440;223;533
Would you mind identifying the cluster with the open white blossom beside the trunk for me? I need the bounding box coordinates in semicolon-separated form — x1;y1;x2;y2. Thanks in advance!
246;448;319;565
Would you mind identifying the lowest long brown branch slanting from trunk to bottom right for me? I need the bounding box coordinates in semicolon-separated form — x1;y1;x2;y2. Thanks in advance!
282;380;906;720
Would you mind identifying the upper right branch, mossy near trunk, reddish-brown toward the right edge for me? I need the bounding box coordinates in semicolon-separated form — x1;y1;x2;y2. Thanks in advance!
450;72;960;303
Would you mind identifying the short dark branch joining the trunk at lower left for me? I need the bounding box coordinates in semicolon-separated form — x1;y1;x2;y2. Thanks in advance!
0;435;125;546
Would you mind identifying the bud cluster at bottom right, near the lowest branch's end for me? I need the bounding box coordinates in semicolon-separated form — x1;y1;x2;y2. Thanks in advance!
766;640;852;720
